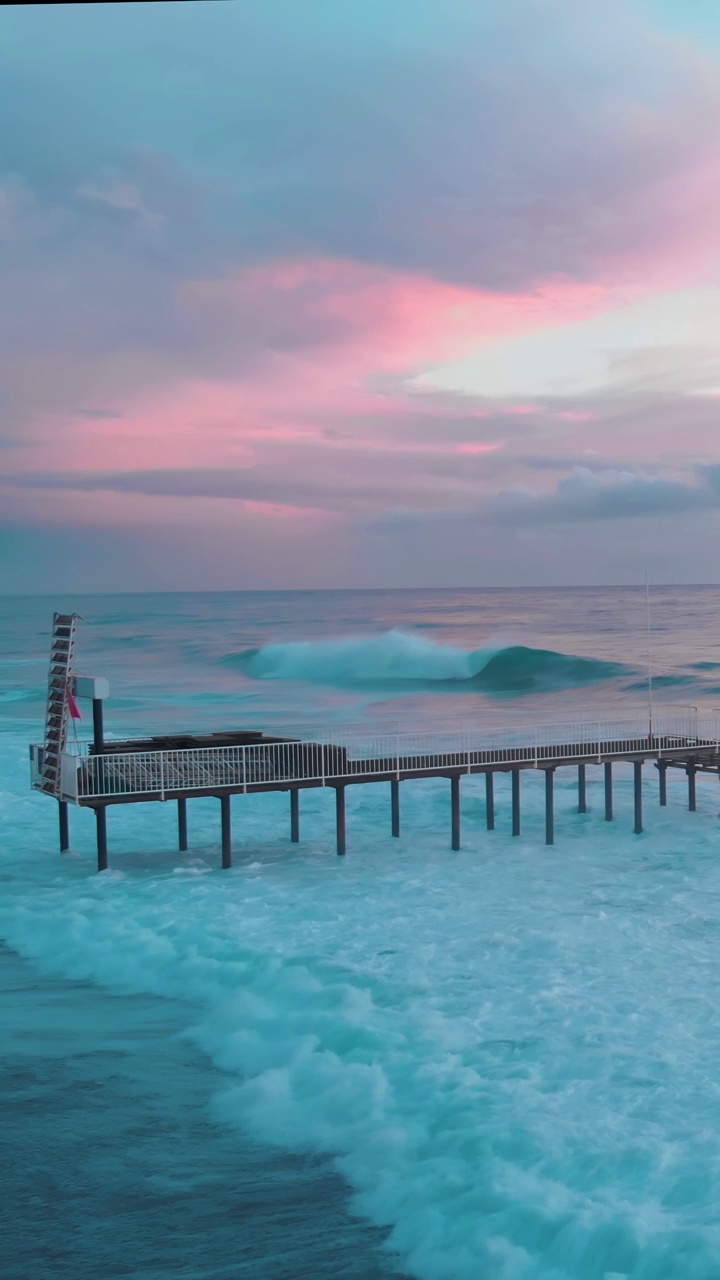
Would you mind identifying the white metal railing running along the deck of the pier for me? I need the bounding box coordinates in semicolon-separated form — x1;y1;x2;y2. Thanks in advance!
31;708;720;804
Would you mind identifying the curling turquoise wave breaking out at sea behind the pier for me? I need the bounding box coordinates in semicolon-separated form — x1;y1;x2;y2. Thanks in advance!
224;631;629;696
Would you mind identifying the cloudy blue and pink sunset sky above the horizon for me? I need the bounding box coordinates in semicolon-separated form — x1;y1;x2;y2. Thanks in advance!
0;0;720;593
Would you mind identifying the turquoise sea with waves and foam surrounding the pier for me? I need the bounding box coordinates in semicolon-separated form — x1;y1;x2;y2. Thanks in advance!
0;586;720;1280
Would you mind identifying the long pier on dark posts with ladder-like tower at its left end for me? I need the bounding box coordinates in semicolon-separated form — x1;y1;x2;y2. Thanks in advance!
31;614;720;870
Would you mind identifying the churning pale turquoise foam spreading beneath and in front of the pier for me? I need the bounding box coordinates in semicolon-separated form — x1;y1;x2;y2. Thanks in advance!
0;737;720;1280
